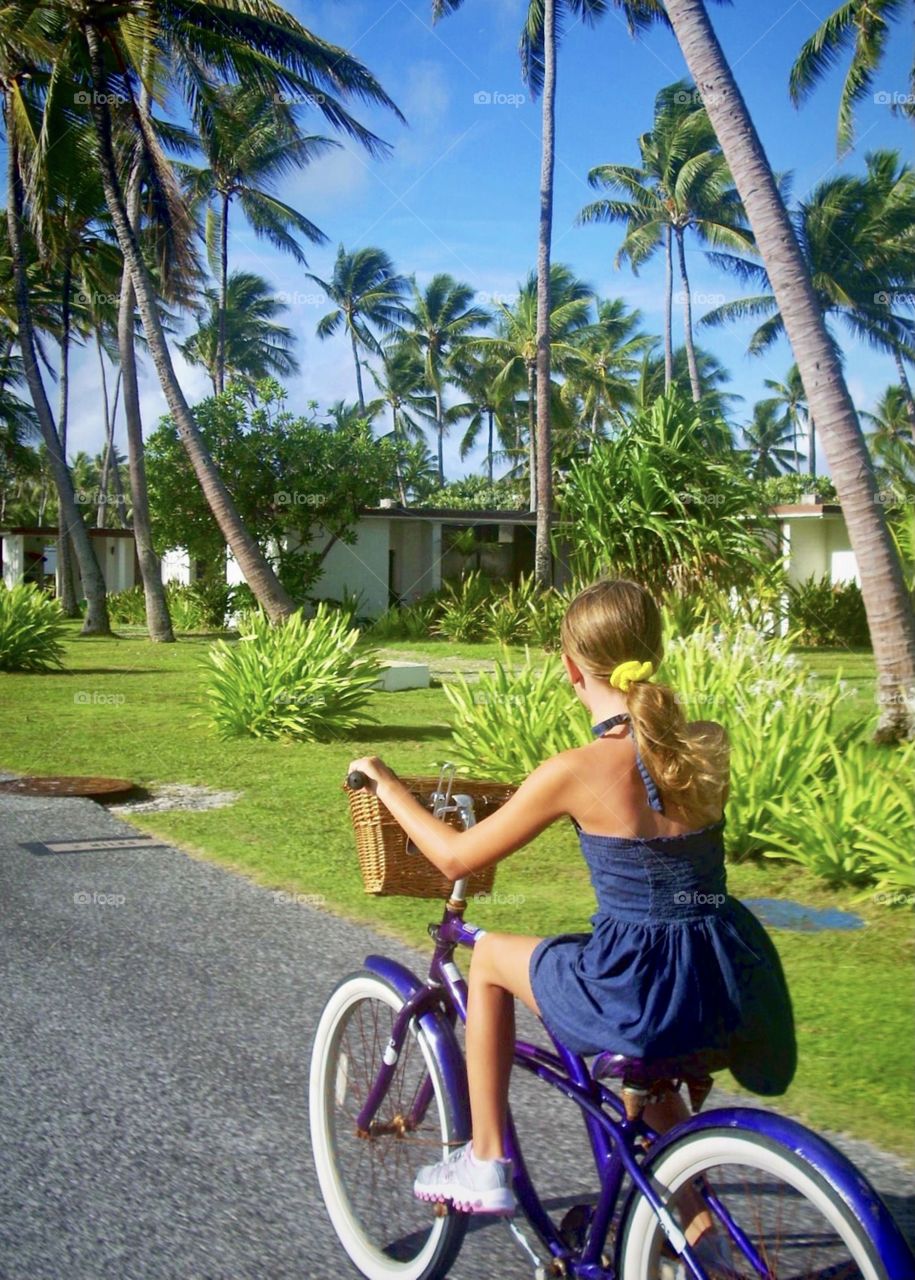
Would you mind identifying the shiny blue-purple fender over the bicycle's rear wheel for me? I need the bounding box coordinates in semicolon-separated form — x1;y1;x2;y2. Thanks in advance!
616;1107;915;1280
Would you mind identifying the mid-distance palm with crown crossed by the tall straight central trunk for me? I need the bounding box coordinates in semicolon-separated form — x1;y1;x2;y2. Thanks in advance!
468;262;594;511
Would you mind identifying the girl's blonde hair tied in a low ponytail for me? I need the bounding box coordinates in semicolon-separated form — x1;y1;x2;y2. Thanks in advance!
561;577;728;820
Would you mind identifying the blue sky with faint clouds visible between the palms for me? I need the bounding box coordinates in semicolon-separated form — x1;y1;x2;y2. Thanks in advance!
59;0;912;476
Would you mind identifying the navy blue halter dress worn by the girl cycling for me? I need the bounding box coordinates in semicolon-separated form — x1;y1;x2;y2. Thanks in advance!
530;714;796;1094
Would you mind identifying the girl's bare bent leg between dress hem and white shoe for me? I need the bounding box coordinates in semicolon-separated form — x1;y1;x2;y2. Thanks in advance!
467;933;540;1160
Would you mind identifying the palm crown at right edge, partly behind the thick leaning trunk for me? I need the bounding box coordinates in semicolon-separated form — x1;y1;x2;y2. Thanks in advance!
703;151;915;438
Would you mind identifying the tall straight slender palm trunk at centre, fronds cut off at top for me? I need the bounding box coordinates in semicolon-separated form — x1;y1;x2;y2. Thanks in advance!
433;0;664;586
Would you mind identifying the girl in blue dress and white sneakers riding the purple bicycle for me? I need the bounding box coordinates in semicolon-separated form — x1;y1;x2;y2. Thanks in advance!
349;580;795;1223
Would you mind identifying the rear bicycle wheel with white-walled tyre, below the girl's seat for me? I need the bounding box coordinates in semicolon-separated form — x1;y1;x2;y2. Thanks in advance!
621;1129;896;1280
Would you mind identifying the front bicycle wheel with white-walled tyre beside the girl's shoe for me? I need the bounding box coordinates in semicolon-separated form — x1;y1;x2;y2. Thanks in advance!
310;972;467;1280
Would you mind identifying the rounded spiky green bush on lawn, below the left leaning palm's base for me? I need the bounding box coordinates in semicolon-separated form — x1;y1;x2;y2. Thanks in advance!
205;603;380;740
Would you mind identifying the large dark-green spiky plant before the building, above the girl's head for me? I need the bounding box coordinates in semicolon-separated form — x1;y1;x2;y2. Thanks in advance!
559;392;767;595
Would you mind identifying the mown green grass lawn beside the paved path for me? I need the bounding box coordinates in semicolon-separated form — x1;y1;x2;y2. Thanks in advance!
0;627;915;1155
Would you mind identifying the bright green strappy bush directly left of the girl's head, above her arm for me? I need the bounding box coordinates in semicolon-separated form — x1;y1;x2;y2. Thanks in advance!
444;650;589;782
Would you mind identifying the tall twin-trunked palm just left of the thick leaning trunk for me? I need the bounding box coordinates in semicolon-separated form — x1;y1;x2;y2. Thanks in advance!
578;81;752;403
